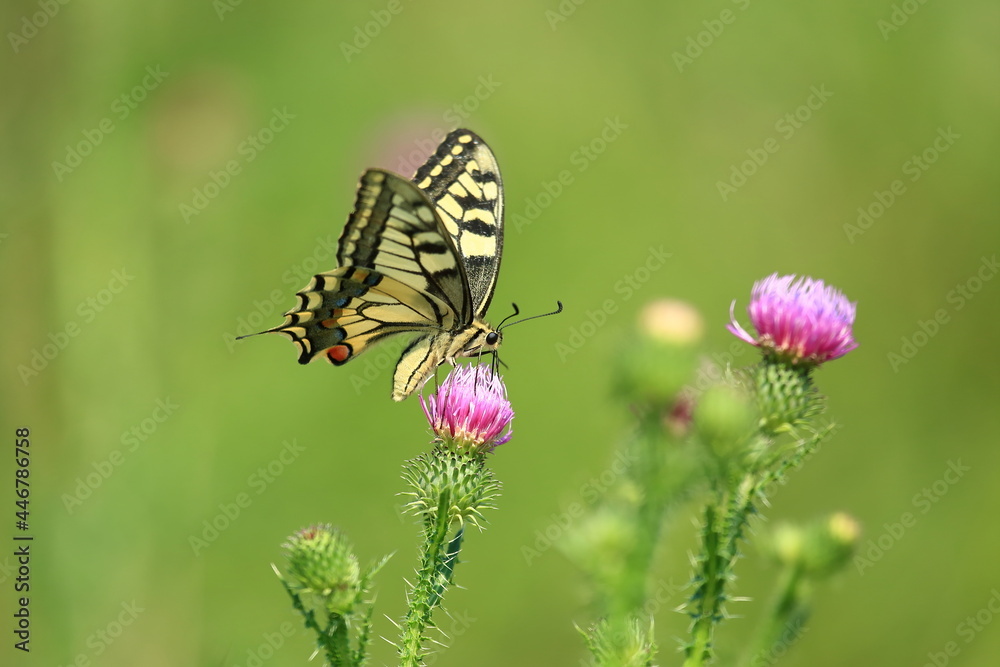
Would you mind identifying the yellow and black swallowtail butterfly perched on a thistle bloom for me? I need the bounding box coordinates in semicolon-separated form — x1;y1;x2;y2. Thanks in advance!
254;129;508;401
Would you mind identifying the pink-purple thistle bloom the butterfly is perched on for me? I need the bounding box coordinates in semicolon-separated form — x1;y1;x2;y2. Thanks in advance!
420;364;514;451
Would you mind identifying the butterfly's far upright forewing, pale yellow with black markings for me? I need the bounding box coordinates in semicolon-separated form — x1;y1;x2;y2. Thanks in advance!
413;129;503;317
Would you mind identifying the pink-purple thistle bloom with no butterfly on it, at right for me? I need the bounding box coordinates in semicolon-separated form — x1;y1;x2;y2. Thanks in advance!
726;273;858;365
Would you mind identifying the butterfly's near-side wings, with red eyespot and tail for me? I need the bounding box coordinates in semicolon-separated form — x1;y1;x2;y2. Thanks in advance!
270;169;472;365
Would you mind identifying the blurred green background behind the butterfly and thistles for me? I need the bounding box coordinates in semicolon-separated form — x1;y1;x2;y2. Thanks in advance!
0;0;1000;666
